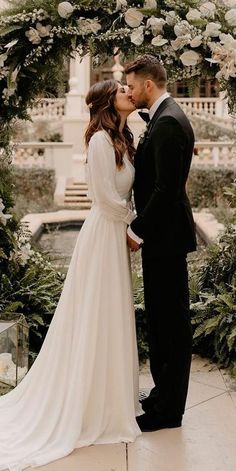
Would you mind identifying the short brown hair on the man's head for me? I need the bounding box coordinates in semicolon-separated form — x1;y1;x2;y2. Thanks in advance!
125;54;167;88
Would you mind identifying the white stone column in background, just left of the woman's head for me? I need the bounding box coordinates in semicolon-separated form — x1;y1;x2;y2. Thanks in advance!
63;55;90;182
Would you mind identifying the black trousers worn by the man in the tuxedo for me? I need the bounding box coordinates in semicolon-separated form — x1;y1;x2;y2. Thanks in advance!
143;253;192;417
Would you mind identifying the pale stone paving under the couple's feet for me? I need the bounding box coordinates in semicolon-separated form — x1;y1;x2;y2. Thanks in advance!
32;356;236;471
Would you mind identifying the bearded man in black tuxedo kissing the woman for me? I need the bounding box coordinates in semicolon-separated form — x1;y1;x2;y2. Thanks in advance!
125;54;196;431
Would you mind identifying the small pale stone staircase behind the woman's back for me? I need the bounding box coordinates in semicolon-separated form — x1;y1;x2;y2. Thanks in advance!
64;179;91;209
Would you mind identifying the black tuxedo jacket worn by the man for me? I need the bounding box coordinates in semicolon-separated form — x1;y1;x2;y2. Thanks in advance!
131;97;196;257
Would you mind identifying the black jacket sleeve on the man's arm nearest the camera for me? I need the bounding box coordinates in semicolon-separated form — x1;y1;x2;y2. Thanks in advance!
131;116;186;238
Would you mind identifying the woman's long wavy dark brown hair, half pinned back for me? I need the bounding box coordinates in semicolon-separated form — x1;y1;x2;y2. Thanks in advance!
85;80;135;167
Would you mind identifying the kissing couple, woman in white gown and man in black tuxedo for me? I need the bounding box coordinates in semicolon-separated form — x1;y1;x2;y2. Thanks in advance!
0;55;196;471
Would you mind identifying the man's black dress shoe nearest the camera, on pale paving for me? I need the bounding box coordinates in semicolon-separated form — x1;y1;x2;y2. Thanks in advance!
136;413;182;432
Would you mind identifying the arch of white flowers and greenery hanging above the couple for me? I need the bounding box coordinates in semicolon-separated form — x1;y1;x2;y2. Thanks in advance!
0;0;236;125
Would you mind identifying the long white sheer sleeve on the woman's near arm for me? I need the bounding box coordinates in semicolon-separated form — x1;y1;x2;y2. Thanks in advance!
88;131;135;224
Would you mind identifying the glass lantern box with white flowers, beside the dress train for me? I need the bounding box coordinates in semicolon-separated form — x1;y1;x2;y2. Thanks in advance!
0;313;29;394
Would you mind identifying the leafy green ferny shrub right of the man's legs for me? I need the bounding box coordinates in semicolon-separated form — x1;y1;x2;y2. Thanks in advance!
190;226;236;372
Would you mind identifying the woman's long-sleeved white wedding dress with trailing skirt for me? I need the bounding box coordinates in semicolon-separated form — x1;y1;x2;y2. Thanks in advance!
0;131;141;471
